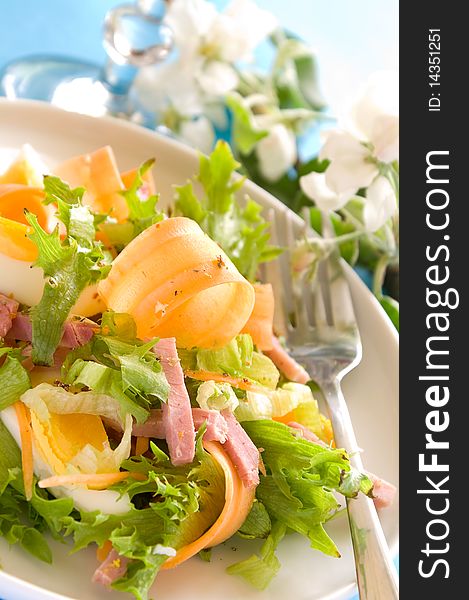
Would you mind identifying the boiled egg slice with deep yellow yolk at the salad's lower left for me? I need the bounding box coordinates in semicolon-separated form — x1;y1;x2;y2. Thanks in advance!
0;384;132;514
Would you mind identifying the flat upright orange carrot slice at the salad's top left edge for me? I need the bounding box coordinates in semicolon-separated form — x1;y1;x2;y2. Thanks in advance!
54;146;129;222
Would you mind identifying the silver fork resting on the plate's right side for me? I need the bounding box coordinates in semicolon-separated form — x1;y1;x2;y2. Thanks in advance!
265;208;399;600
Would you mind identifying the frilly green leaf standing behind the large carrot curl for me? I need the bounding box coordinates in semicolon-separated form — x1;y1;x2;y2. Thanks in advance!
176;140;282;281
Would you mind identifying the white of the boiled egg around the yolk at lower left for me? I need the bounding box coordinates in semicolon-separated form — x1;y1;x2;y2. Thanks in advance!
0;406;132;515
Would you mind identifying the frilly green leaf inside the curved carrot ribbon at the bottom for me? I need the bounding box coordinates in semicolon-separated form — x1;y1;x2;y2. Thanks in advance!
64;431;225;600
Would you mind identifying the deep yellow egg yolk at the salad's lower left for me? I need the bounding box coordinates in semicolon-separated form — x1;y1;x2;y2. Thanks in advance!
31;412;108;475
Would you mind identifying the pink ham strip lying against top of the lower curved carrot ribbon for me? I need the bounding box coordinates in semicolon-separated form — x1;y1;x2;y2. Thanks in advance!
222;409;260;488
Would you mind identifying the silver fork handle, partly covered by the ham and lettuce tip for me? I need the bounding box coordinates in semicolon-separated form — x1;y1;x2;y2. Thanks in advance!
321;379;399;600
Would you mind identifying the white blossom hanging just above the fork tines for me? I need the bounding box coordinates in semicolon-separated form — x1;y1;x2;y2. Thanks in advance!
319;131;378;195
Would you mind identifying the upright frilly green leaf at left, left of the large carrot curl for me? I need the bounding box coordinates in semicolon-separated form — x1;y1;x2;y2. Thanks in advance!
26;175;111;366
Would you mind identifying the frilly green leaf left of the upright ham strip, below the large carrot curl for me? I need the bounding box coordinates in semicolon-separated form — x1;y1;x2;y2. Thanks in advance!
62;313;169;423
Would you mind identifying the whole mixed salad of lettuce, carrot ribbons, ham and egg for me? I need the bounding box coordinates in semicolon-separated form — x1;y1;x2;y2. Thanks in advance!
0;142;394;600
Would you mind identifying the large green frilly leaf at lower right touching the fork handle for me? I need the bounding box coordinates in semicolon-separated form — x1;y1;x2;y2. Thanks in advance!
242;420;372;557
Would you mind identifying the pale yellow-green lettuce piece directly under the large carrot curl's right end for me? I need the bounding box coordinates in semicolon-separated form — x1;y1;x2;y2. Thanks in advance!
178;333;280;389
